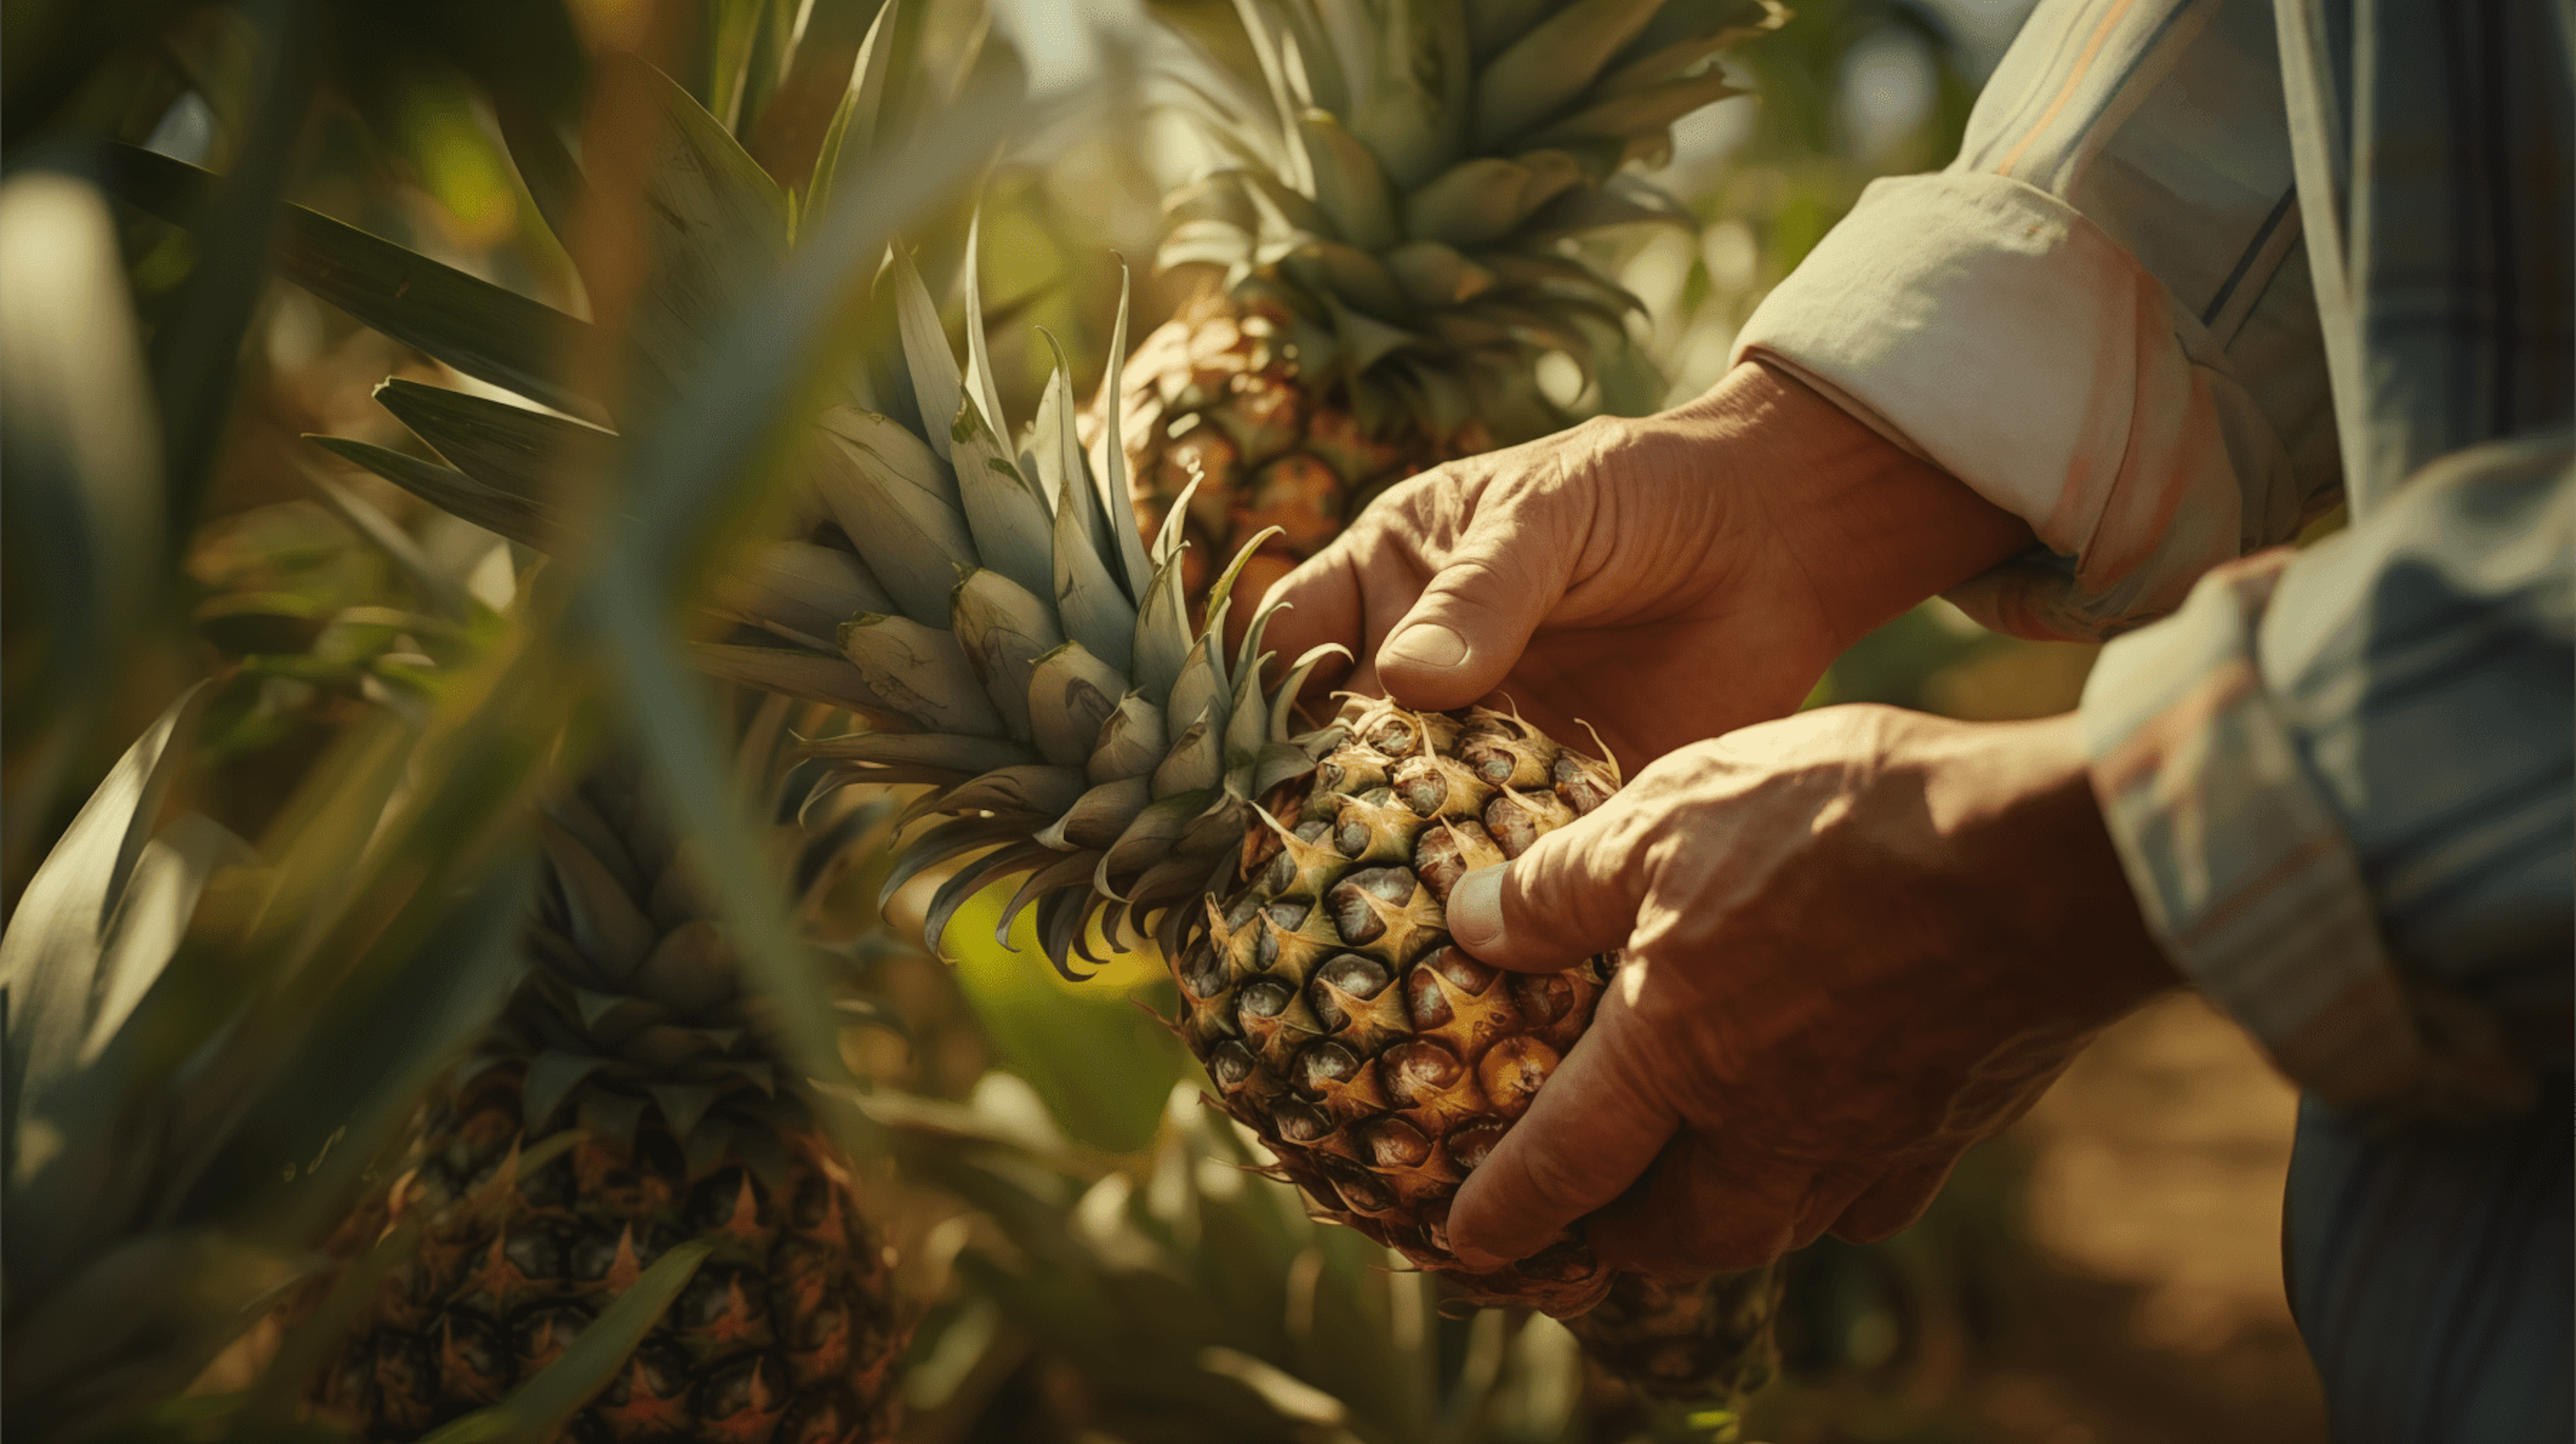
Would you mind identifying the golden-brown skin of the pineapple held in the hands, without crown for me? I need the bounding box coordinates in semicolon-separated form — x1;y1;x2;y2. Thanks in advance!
1169;701;1618;1318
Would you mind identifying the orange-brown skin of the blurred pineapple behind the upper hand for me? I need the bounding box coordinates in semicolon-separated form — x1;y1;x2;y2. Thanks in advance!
1085;287;1494;609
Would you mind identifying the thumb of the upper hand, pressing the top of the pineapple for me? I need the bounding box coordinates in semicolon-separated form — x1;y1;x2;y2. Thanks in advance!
1376;508;1574;712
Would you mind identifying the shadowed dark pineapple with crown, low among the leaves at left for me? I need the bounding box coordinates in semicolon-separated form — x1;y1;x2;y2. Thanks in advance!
314;761;907;1444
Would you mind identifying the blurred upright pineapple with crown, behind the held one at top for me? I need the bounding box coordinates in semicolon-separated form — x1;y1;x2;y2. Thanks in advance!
1097;0;1785;613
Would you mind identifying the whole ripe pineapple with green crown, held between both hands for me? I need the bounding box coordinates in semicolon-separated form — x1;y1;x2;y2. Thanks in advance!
700;234;1669;1315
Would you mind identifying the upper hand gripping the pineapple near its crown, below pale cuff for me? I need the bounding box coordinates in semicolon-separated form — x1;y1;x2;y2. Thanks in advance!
1267;361;2030;766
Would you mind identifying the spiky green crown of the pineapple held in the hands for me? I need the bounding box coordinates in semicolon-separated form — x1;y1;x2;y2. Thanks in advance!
698;232;1337;970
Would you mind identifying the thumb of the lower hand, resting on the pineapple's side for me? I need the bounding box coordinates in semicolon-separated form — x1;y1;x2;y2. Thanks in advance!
1448;792;1656;972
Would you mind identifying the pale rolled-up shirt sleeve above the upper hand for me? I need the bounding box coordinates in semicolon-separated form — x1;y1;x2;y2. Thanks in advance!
1736;0;2339;639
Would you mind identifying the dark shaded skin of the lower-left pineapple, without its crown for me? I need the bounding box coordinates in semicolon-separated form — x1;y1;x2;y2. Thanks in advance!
314;1068;904;1444
